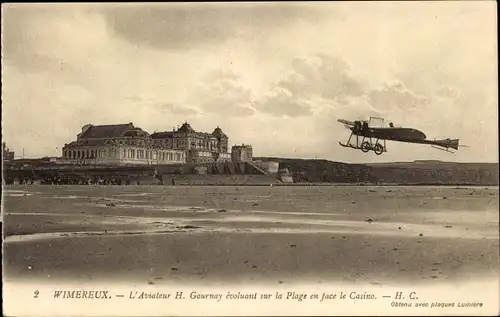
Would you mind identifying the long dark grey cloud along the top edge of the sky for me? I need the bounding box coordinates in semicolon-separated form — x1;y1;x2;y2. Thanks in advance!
101;3;322;50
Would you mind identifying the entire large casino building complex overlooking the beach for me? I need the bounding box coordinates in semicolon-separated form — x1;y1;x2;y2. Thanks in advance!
60;122;231;165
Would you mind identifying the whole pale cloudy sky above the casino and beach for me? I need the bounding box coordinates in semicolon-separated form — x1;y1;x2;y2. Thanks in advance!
2;1;498;162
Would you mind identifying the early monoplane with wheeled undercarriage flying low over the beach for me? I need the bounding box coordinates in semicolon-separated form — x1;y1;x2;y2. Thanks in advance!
337;117;465;155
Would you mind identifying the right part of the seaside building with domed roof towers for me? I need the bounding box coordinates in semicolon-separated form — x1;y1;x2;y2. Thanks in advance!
151;122;231;164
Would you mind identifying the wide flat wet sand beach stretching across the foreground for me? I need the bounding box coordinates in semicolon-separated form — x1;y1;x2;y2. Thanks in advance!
3;186;499;285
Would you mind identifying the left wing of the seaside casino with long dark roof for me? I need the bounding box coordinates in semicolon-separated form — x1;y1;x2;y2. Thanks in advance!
61;122;186;165
